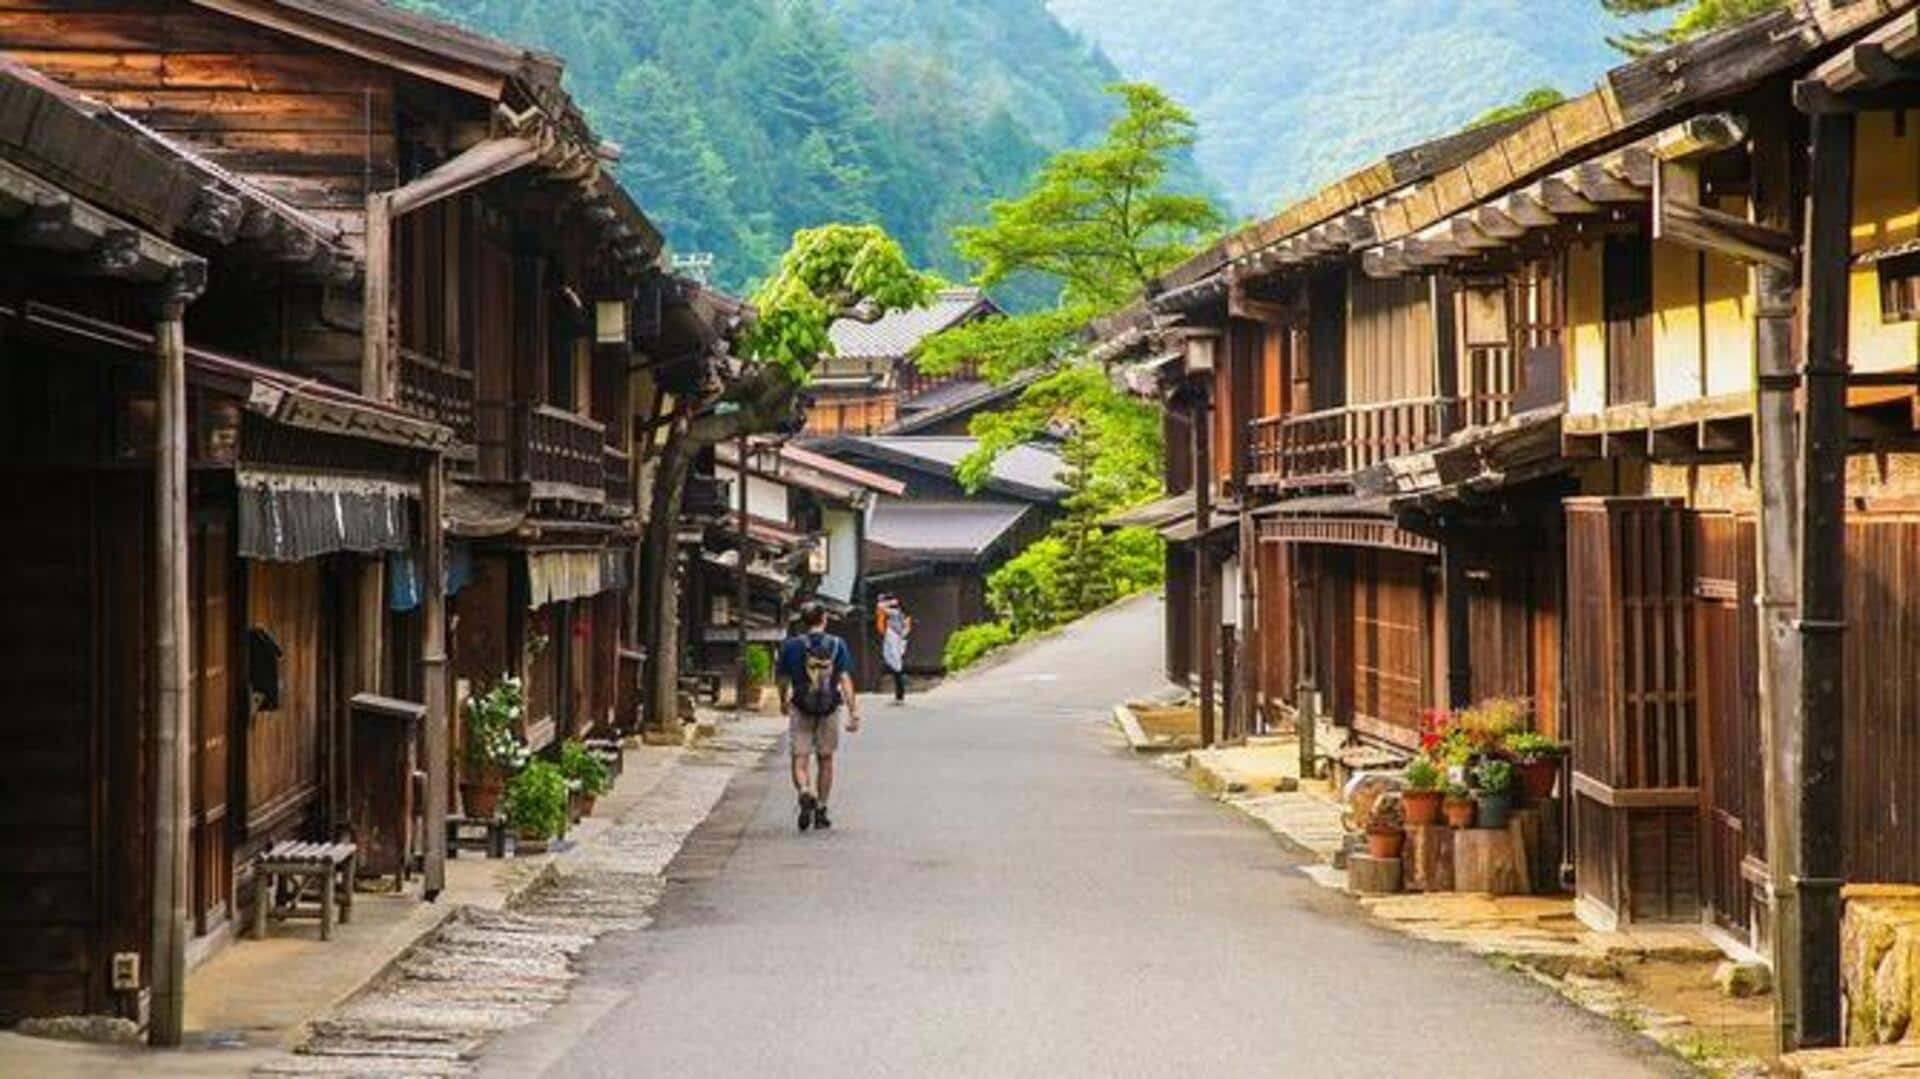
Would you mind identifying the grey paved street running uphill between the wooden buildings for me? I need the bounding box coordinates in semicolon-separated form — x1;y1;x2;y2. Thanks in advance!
482;597;1676;1079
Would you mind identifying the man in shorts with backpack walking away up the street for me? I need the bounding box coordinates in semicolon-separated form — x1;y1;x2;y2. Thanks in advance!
774;603;860;831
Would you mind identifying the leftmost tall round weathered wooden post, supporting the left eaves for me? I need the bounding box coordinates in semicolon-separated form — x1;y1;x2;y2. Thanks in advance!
148;267;205;1046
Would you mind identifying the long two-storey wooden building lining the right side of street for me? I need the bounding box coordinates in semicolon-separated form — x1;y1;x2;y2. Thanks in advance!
1094;0;1920;1044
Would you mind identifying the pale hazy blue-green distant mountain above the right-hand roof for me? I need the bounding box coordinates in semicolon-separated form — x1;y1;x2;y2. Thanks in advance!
1048;0;1645;213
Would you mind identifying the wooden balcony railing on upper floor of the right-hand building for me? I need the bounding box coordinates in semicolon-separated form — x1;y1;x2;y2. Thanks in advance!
1250;397;1461;488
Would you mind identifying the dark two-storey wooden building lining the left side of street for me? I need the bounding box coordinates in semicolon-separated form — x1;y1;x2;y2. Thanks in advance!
0;0;739;1041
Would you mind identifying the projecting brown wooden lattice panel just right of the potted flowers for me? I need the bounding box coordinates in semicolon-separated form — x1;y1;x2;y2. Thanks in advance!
1567;499;1701;925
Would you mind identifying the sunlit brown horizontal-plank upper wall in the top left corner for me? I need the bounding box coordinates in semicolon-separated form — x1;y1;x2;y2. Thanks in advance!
0;0;396;238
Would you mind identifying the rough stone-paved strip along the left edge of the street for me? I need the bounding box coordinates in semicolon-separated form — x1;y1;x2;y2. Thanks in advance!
255;720;778;1075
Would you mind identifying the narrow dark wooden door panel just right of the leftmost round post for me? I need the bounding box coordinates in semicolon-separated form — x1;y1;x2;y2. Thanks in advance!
188;511;234;933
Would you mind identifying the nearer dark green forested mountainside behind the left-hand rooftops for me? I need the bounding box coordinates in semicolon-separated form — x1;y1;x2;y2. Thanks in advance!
403;0;1117;288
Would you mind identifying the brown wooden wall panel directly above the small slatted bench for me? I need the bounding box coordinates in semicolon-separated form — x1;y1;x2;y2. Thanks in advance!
246;561;330;843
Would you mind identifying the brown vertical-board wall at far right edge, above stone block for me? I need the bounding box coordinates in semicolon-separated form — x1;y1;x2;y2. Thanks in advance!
1841;515;1920;883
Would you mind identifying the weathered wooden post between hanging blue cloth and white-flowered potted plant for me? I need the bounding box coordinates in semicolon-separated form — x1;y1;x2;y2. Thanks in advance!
420;455;453;899
